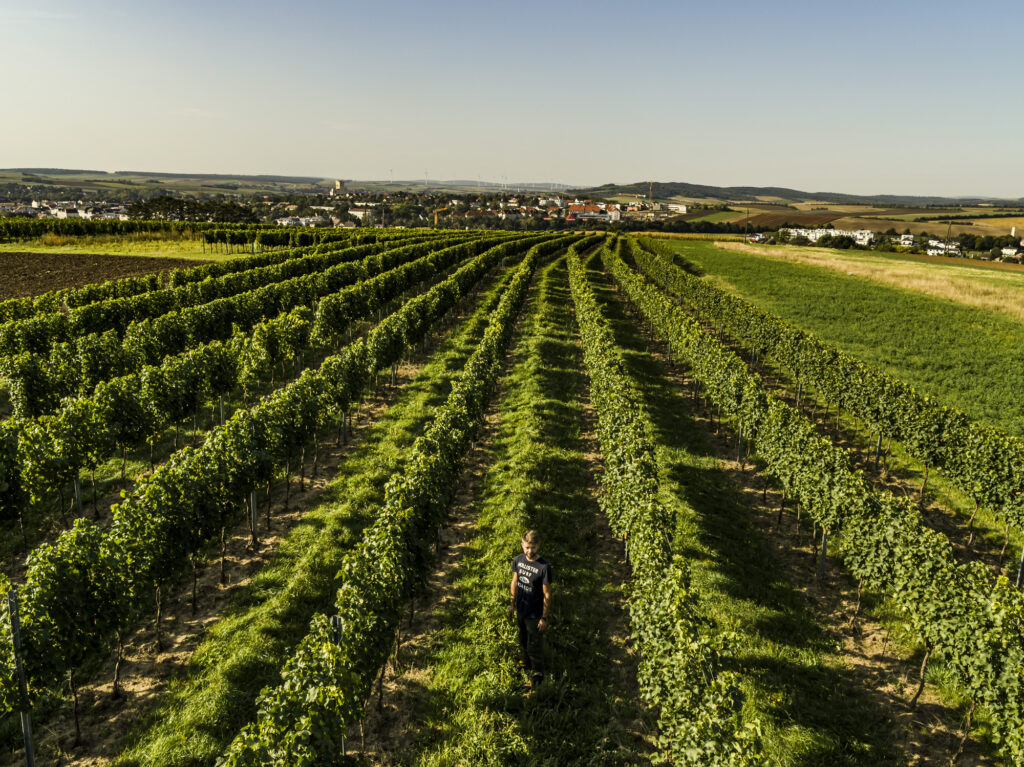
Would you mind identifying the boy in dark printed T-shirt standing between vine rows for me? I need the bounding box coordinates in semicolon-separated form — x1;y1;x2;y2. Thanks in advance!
509;530;554;688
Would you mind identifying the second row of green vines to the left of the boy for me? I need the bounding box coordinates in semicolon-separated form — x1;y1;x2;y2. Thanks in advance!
0;233;552;737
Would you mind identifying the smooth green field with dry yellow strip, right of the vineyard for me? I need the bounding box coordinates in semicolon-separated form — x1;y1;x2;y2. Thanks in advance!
651;237;1024;435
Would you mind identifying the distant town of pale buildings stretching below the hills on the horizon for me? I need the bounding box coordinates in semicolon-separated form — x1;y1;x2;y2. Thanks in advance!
0;181;1024;263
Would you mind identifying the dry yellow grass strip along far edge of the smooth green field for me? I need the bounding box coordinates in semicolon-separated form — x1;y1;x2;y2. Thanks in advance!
715;242;1024;321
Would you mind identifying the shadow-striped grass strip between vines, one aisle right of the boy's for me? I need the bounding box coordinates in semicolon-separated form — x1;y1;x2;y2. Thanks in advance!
590;240;897;767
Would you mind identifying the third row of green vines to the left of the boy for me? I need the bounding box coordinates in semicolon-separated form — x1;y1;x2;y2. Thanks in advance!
0;239;497;581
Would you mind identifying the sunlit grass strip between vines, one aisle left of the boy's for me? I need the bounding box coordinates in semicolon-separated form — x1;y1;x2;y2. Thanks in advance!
108;245;532;767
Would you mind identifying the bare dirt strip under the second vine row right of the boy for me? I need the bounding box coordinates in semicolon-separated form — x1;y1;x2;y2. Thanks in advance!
598;262;991;765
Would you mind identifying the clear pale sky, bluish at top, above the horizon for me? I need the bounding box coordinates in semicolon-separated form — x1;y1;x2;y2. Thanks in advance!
0;0;1024;198
